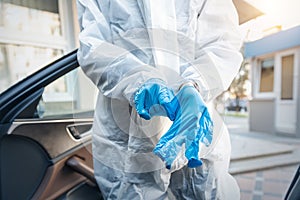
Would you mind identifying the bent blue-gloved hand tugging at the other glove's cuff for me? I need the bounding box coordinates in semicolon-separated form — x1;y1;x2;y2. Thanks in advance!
134;79;175;121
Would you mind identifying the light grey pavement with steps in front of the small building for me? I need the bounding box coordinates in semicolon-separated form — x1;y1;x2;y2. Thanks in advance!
223;116;300;200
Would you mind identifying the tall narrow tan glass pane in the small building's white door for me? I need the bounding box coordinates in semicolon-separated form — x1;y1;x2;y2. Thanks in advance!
281;55;294;100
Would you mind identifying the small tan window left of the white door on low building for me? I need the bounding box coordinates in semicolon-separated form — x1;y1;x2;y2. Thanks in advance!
259;58;274;93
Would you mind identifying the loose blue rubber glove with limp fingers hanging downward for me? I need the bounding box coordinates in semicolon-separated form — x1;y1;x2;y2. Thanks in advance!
153;86;213;169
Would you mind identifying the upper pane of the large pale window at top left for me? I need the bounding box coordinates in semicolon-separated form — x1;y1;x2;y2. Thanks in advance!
0;0;62;38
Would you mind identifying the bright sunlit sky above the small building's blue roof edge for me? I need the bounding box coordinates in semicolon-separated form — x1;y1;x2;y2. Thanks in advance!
241;0;300;41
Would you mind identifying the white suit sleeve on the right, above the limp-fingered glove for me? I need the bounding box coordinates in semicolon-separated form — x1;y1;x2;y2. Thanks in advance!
182;0;242;101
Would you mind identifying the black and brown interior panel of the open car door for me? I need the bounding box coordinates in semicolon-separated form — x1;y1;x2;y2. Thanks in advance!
0;119;101;199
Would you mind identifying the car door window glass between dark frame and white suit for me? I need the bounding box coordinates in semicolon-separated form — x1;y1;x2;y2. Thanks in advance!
37;68;98;119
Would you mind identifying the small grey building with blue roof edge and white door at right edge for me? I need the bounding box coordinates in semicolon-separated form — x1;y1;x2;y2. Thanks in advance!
245;26;300;137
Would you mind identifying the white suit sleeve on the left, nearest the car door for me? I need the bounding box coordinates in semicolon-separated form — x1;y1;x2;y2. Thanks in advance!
77;0;165;105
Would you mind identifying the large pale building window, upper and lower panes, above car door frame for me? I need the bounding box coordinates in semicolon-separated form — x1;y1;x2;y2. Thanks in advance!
0;0;66;93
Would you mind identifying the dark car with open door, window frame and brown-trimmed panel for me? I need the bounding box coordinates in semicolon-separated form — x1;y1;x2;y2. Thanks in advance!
0;50;300;200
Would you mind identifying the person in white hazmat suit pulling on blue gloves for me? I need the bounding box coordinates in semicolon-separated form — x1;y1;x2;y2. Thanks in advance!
77;0;242;200
